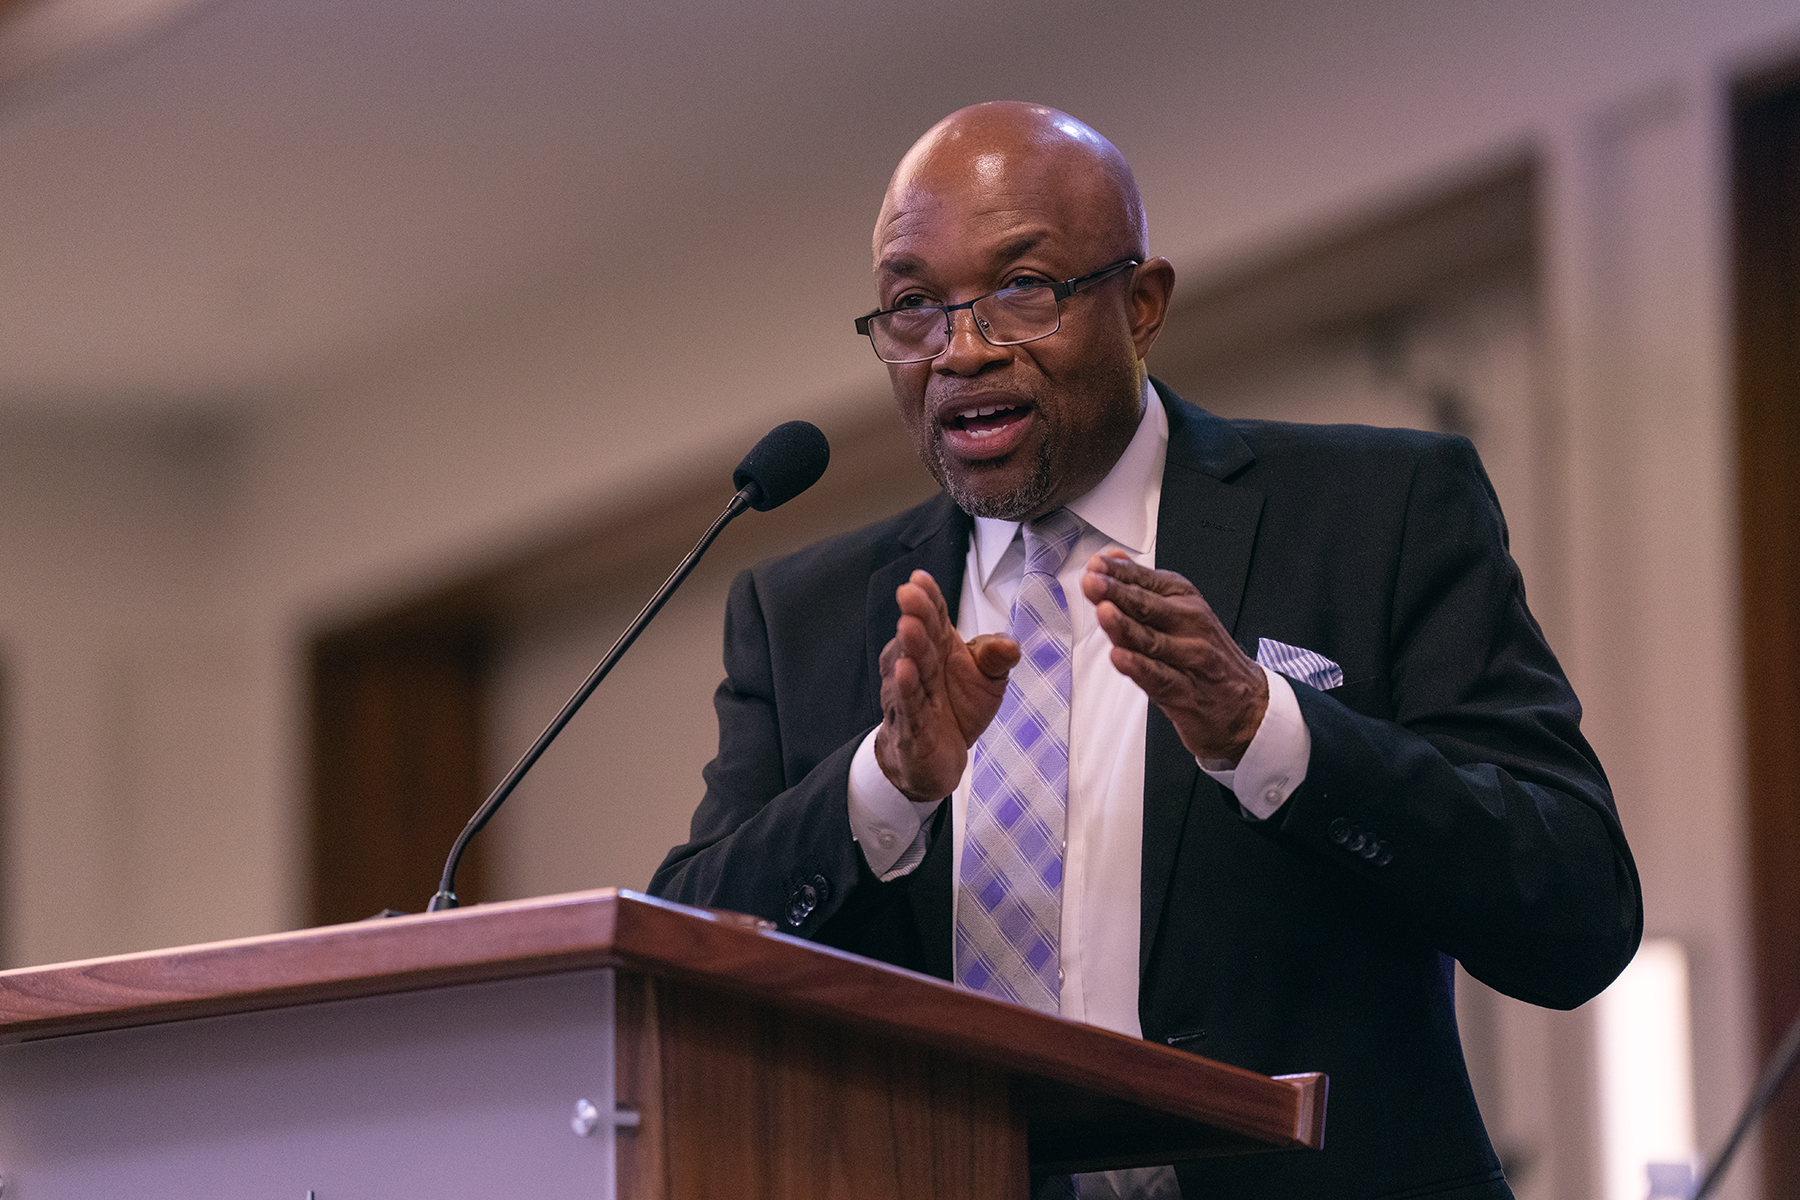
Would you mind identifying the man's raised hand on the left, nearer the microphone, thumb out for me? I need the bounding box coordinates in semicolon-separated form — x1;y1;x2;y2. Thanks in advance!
875;570;1019;801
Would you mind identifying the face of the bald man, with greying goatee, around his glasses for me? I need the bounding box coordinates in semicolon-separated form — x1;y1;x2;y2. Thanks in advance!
875;153;1141;520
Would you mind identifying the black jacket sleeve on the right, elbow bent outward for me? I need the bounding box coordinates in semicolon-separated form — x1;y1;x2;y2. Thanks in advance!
1271;439;1643;1007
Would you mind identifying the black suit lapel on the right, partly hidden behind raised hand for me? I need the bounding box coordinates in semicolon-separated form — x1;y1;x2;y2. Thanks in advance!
1138;383;1262;979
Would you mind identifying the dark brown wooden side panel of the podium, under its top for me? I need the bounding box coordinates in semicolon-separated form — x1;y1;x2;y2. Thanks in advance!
633;977;1030;1200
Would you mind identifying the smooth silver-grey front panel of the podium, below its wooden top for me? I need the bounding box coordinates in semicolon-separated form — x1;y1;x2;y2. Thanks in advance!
0;968;617;1200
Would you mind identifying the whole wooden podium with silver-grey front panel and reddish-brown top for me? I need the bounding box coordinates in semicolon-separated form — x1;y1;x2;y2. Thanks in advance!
0;889;1325;1200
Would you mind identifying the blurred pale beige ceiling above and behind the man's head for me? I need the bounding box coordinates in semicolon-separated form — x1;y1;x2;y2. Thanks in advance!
0;0;1764;412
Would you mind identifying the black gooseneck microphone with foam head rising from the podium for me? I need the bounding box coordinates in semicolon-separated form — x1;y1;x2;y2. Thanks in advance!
425;421;832;912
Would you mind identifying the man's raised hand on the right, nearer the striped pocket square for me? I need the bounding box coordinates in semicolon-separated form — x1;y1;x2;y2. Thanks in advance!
1082;549;1269;770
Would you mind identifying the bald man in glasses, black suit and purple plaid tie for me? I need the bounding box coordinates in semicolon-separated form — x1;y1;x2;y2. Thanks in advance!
652;104;1642;1200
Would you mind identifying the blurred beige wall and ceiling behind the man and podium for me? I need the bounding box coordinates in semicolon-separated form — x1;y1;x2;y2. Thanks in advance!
0;0;1800;1200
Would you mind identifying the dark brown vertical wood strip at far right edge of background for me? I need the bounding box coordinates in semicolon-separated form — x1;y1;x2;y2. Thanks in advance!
1732;65;1800;1200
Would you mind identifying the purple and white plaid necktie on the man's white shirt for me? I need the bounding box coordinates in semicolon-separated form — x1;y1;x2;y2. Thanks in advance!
956;509;1082;1013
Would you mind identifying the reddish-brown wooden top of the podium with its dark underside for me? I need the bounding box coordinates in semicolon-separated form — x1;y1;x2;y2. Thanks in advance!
0;889;1323;1169
